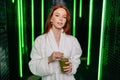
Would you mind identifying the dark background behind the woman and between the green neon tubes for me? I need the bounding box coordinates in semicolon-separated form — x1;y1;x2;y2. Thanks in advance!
0;0;120;80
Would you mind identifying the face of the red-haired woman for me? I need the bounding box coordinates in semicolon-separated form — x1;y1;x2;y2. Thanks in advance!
50;8;67;29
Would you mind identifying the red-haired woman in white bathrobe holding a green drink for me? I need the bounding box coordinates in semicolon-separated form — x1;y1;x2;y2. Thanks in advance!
29;4;82;80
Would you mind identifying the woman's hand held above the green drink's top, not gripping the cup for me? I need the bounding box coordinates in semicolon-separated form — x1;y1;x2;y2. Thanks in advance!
48;52;63;63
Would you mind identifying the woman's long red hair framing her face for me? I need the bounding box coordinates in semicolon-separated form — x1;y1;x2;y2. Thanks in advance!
45;4;71;34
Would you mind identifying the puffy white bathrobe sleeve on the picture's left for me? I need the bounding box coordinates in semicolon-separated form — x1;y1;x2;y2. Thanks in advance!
29;37;50;76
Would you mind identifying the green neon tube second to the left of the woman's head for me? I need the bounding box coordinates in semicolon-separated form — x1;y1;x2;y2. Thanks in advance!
31;0;34;45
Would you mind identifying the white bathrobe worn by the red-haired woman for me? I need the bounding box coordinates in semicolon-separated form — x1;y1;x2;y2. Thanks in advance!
29;30;82;80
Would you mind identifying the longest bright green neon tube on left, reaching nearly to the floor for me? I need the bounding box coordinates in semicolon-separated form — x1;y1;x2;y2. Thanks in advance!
17;0;23;77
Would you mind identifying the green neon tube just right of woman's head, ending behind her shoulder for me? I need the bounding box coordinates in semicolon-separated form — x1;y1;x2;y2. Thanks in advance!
73;0;76;36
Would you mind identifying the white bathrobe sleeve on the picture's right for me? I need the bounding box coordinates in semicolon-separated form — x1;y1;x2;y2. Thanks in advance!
70;37;82;74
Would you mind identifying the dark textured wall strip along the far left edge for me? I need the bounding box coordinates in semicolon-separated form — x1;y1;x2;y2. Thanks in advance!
0;0;10;80
